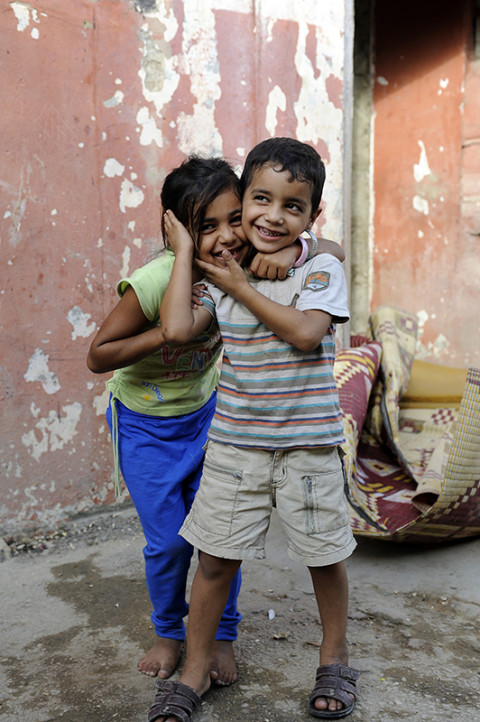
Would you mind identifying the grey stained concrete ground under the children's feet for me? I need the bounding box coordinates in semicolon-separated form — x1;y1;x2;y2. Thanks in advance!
0;500;480;722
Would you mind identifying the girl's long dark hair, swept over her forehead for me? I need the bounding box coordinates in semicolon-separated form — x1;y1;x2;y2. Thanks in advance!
160;155;240;249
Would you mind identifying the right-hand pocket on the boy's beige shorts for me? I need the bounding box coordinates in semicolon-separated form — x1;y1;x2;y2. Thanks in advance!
302;467;350;535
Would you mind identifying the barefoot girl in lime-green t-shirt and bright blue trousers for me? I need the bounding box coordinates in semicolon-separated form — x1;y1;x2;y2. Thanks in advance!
87;156;334;685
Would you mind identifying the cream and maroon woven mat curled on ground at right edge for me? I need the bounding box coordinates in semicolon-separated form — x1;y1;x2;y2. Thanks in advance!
344;306;480;543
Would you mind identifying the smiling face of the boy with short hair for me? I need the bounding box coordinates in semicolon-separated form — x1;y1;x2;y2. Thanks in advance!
242;165;319;253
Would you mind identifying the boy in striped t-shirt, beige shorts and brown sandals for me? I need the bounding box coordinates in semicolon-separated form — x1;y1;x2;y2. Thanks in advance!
149;138;359;722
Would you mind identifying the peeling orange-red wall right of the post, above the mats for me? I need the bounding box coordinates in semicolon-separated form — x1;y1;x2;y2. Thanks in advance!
370;0;480;366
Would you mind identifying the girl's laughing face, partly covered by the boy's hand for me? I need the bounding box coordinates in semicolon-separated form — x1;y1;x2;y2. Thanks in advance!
198;190;250;266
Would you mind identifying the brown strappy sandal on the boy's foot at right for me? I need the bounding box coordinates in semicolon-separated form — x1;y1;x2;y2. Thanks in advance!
308;664;360;719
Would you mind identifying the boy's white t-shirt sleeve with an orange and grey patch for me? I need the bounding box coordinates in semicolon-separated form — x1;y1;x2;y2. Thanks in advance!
295;253;350;323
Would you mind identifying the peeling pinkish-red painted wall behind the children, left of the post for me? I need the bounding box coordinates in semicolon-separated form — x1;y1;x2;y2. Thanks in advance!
0;0;352;531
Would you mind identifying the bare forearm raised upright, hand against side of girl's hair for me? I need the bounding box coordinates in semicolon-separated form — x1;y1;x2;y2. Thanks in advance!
160;211;212;345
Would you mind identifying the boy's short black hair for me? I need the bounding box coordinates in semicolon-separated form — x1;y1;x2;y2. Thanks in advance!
240;138;325;211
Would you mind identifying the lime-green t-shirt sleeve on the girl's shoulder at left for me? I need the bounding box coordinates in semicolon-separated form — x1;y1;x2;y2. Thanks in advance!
117;253;173;321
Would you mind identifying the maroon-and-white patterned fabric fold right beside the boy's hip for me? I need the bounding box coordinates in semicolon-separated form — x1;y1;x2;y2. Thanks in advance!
333;341;382;480
